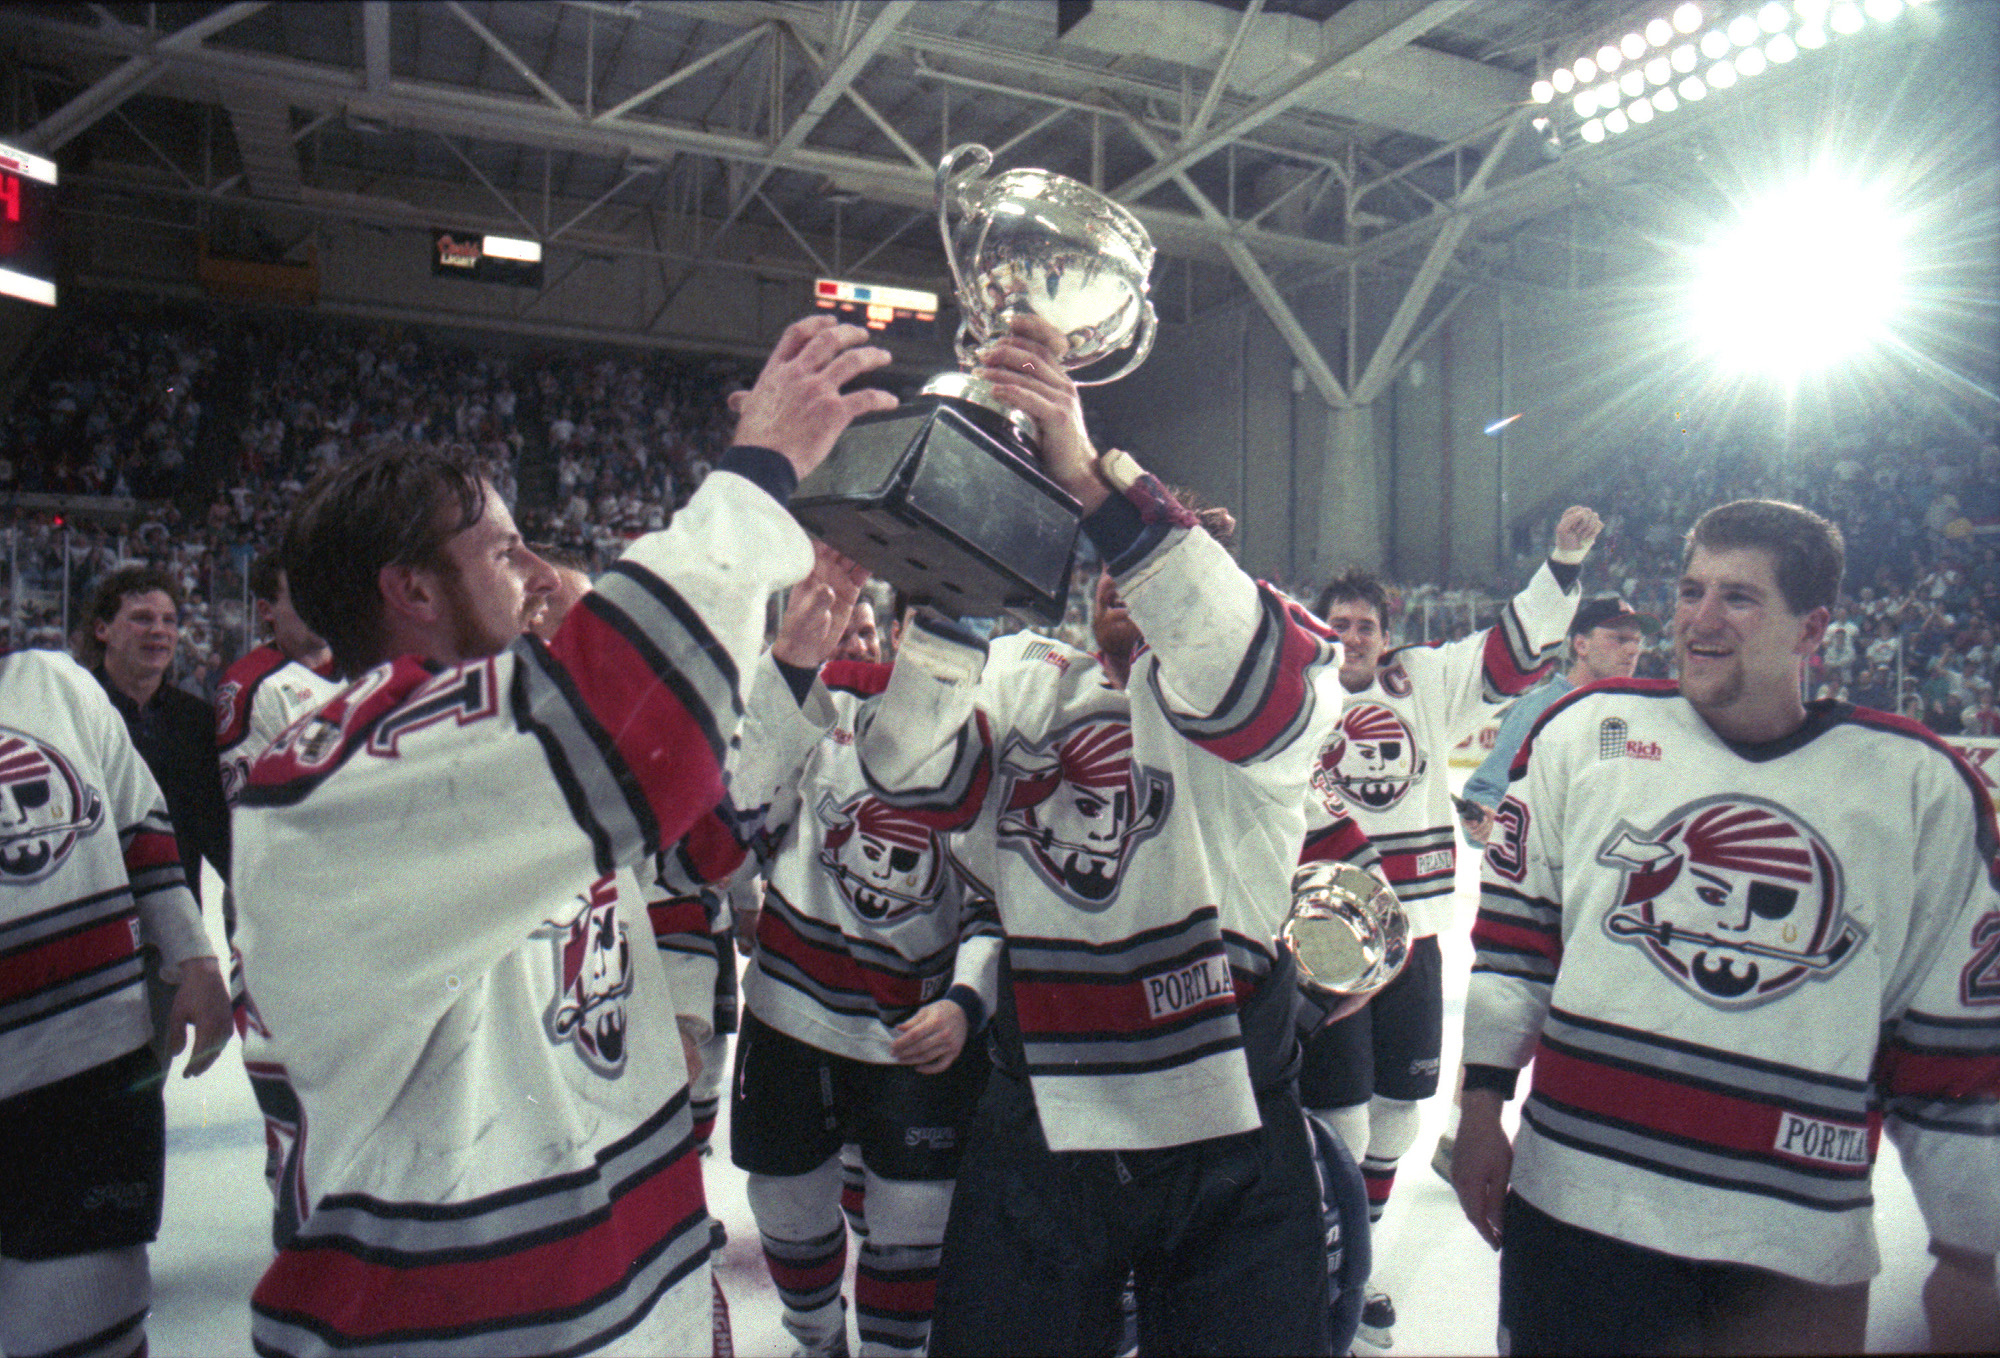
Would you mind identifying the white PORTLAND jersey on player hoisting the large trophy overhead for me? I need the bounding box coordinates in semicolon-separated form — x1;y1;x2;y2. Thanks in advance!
860;528;1340;1150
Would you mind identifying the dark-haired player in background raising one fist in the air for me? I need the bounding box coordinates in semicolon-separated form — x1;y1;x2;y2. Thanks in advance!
1300;506;1602;1348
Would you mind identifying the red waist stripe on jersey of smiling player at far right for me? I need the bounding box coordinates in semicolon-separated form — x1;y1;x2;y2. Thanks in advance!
1534;1042;1880;1178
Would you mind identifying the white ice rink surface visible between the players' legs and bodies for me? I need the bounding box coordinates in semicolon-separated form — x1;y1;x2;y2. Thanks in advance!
148;770;1928;1358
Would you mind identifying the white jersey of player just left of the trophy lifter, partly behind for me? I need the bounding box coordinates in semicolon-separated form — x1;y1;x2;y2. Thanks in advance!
730;652;1000;1066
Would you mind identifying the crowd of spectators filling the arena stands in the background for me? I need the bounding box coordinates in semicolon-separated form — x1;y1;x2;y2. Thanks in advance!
0;302;2000;734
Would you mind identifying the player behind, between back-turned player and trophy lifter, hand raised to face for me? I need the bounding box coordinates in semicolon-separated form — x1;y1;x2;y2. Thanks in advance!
730;548;1000;1354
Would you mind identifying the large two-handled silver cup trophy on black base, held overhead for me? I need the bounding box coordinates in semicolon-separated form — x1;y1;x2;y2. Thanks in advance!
792;146;1158;622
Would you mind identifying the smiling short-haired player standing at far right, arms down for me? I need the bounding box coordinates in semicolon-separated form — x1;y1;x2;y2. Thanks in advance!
1454;500;2000;1354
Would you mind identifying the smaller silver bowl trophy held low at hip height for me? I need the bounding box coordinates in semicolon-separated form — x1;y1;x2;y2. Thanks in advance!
1280;862;1410;1000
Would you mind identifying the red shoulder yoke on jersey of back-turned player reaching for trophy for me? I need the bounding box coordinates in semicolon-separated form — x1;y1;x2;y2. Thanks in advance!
242;656;500;806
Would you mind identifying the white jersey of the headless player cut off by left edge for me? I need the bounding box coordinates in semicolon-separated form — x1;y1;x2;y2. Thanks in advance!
0;650;214;1098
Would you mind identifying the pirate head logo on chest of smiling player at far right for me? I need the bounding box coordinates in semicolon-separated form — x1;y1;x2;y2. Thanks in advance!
1598;796;1866;1010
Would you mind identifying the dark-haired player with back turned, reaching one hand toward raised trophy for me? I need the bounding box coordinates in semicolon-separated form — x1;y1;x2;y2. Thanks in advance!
236;316;894;1356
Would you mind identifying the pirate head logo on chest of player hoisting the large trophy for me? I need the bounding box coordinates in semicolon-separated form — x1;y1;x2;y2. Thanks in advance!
998;718;1174;912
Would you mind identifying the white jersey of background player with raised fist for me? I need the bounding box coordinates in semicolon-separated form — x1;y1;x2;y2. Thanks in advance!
1306;562;1580;938
